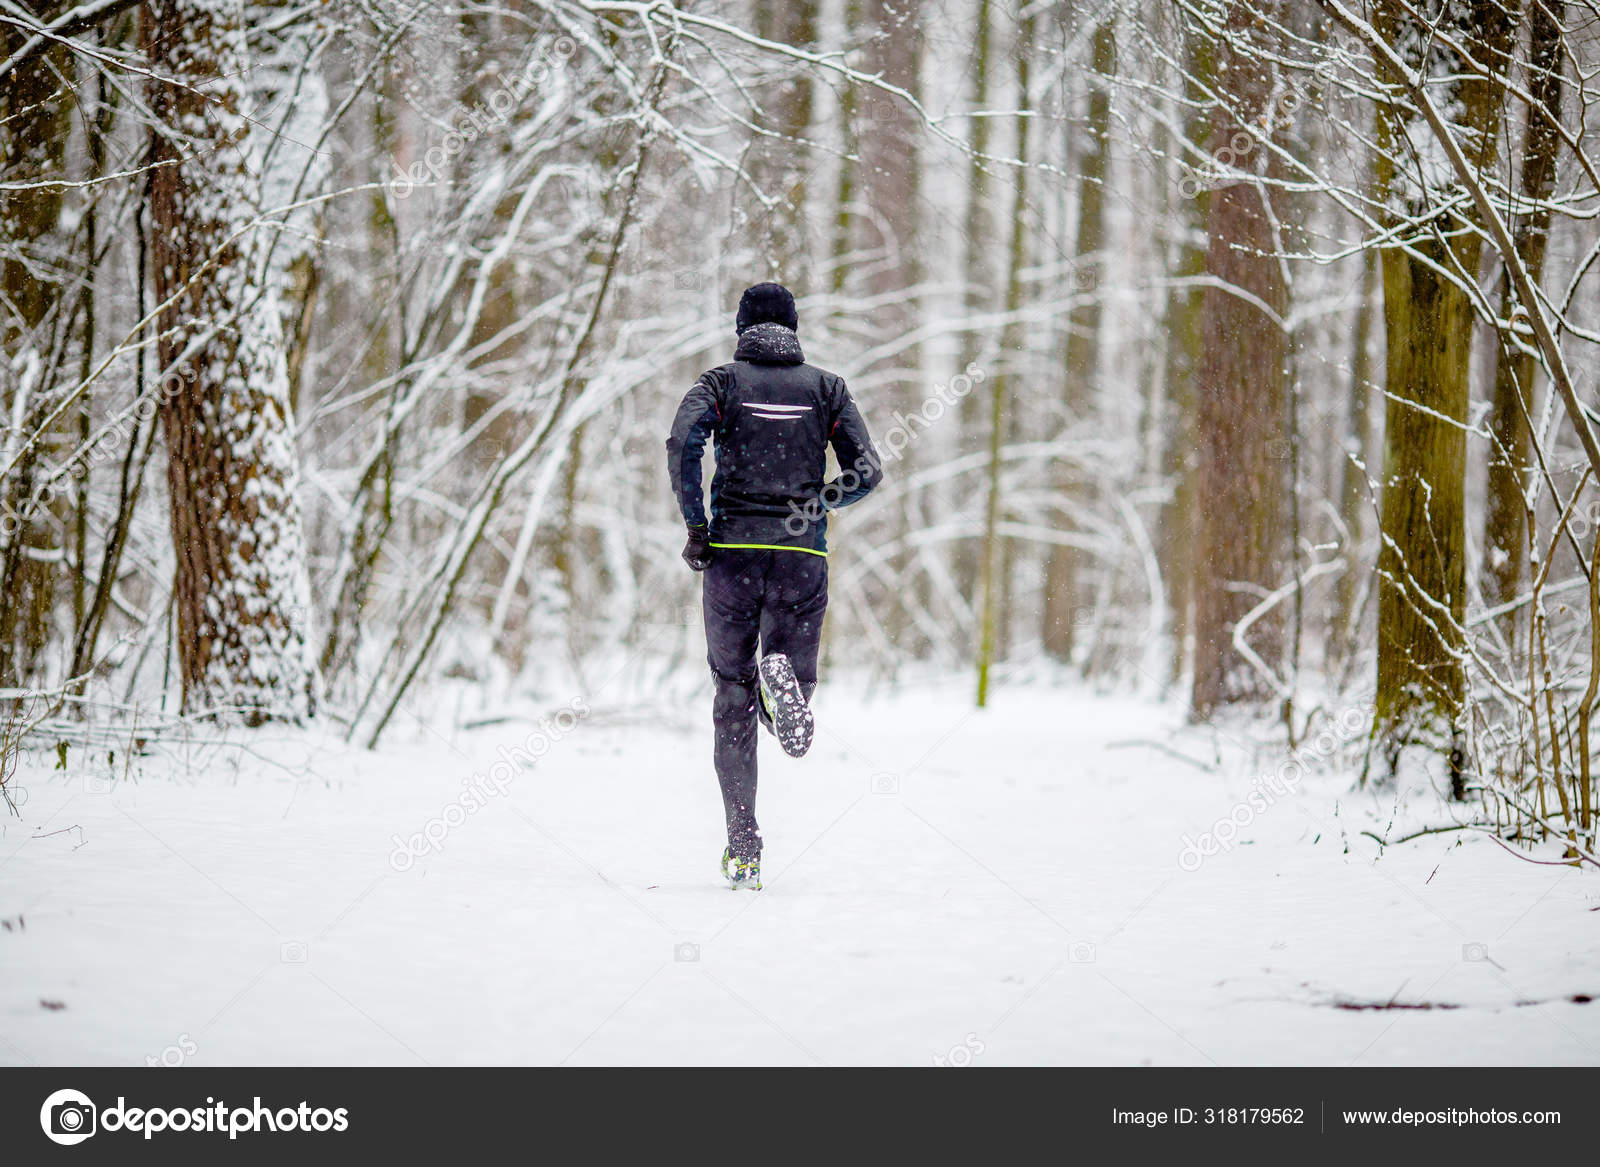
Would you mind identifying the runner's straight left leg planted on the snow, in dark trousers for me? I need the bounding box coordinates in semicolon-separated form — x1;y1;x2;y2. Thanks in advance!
701;551;773;860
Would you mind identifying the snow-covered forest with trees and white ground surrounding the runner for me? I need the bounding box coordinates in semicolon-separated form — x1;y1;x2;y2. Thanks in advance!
9;0;1600;1065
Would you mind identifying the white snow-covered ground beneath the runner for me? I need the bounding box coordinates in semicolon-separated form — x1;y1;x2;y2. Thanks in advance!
0;682;1600;1066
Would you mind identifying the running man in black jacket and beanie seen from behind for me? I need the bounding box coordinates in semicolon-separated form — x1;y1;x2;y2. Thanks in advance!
667;283;883;892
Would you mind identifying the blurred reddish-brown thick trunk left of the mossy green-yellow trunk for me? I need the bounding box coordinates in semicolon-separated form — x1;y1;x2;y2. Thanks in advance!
1190;3;1290;717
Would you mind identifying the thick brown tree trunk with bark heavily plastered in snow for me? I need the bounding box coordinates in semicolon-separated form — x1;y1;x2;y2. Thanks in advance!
144;0;314;724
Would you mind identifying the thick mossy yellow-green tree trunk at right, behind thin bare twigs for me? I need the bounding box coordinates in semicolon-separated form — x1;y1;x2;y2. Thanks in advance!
1374;0;1514;765
